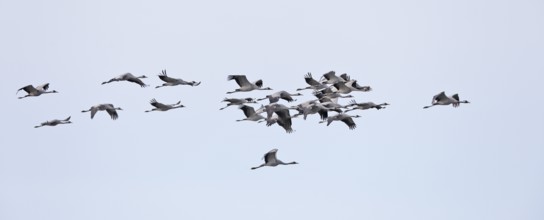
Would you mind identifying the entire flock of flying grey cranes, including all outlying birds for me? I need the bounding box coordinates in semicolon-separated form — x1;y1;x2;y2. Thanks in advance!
17;70;470;169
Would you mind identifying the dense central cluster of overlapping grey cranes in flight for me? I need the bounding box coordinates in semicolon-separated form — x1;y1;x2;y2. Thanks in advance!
220;71;389;133
